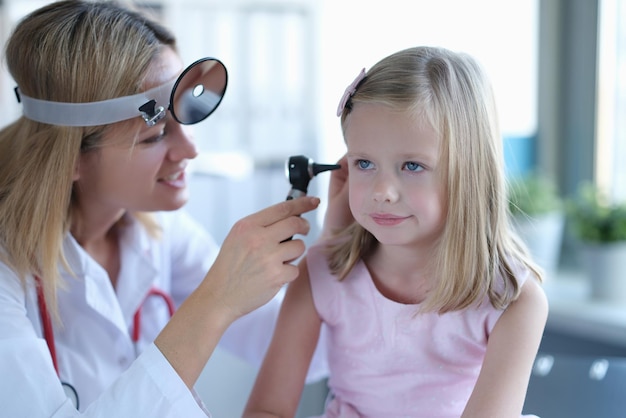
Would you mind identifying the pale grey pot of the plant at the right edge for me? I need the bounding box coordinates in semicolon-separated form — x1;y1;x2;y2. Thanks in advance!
580;241;626;304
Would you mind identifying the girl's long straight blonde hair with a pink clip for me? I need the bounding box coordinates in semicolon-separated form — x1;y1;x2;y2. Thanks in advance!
329;47;542;313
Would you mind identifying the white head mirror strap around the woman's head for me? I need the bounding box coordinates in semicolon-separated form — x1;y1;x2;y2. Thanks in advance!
15;80;176;126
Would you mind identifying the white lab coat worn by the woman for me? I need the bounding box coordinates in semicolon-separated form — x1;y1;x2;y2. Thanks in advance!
0;211;326;418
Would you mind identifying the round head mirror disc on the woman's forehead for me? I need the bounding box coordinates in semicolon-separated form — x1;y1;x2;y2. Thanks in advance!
170;58;228;125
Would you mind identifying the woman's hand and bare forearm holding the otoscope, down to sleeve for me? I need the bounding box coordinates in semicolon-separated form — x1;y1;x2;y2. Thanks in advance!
155;196;320;389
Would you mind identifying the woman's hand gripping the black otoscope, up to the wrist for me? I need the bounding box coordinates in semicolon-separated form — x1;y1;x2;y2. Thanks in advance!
205;197;319;320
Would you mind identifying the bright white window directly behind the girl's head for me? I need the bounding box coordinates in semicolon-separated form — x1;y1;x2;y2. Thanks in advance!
318;0;539;178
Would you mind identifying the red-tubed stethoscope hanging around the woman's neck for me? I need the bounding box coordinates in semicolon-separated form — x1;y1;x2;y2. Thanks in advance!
35;277;176;410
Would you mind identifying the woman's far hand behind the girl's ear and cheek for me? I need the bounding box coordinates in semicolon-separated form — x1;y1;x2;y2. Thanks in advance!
321;155;354;239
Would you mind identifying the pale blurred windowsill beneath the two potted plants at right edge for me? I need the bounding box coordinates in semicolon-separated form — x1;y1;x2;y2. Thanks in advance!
544;272;626;347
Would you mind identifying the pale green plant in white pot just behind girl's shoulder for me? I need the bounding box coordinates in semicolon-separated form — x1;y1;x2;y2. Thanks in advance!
508;172;565;276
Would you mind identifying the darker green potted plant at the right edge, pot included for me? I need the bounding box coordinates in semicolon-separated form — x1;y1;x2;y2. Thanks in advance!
567;183;626;303
